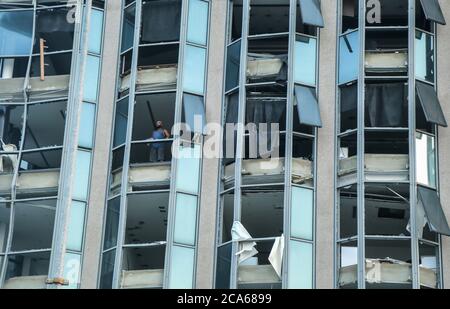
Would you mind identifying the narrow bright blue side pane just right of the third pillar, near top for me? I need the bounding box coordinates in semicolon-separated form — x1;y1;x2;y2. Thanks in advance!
339;31;359;85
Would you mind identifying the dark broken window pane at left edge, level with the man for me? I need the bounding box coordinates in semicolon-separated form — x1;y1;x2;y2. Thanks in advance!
0;105;24;151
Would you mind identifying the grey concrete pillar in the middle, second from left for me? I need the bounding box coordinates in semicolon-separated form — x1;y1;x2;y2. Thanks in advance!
196;0;227;289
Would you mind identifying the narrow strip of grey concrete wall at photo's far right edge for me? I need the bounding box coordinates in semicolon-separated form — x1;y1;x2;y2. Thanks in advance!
437;0;450;289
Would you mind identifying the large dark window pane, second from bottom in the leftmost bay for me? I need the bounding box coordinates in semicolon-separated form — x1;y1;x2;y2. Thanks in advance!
11;200;56;251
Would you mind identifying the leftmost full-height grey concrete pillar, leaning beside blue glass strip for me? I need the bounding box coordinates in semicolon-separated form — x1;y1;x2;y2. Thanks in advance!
81;1;121;289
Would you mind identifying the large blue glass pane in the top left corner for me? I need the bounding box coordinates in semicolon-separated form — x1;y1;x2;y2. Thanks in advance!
0;11;33;56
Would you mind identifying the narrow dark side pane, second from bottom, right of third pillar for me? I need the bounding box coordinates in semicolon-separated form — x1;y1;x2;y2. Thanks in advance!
338;185;358;240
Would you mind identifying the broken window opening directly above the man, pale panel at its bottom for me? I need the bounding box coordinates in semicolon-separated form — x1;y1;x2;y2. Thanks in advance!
136;44;178;92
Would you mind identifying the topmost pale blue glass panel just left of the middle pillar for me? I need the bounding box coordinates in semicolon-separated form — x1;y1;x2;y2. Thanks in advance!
187;0;208;46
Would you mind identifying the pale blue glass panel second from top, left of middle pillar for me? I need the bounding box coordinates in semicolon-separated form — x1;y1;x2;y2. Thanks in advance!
183;45;206;94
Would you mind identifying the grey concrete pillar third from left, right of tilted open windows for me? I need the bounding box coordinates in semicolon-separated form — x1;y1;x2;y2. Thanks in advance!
316;1;338;289
